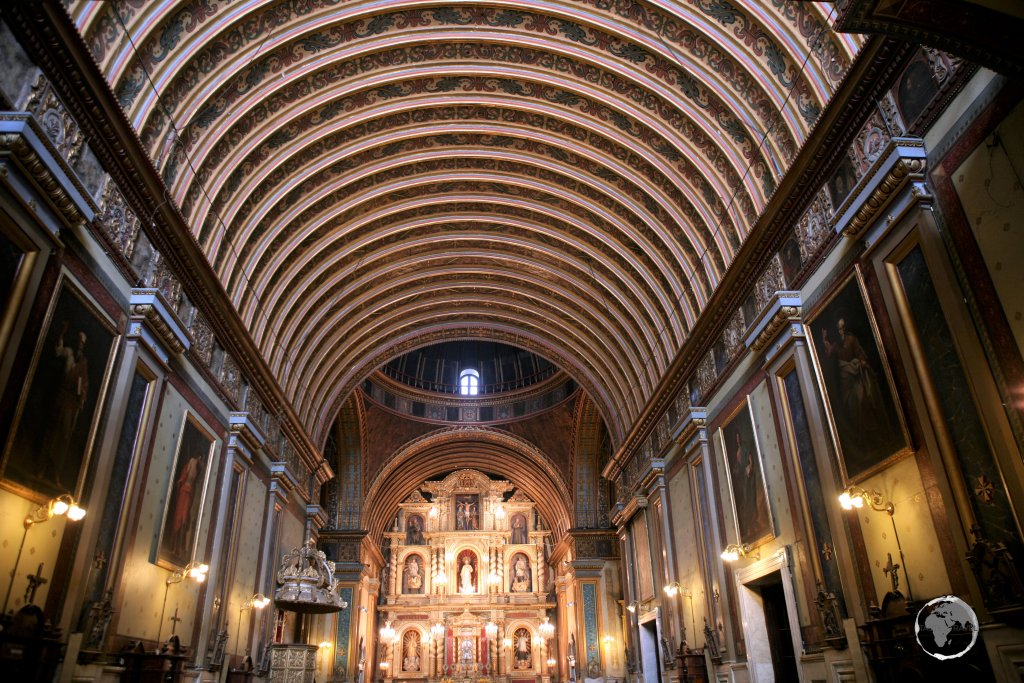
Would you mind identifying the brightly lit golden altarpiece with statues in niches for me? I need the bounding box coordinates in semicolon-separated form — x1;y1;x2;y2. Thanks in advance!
381;470;555;681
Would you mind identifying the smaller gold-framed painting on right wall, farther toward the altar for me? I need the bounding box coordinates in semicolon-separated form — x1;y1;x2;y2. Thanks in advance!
719;396;775;548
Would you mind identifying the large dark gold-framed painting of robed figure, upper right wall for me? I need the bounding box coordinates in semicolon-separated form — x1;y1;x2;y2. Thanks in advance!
807;272;909;480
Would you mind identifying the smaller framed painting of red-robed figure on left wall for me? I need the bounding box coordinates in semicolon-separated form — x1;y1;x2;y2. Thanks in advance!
157;413;215;569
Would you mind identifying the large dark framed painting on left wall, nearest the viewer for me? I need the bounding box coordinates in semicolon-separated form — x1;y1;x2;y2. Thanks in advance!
2;273;118;500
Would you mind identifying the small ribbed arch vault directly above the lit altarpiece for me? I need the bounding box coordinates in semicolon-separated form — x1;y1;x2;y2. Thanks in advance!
362;427;572;542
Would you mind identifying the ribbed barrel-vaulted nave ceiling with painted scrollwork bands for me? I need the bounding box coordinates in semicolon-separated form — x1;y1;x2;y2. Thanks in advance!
68;0;859;441
